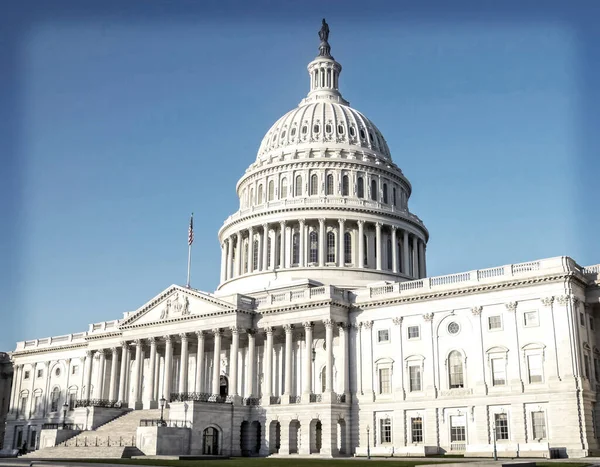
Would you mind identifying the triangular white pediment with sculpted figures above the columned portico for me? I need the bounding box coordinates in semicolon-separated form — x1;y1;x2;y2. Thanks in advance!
119;285;235;328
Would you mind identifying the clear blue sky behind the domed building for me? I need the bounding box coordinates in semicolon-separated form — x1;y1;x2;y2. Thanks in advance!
0;0;600;350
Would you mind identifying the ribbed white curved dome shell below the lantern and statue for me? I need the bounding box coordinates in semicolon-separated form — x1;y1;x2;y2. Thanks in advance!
257;102;391;161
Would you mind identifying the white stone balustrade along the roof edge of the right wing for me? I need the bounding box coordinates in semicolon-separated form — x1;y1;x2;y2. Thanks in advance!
359;257;600;300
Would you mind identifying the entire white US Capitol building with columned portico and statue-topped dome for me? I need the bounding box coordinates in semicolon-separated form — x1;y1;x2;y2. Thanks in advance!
4;21;600;457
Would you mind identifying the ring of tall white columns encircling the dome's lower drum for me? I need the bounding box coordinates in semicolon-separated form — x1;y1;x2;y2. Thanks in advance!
221;218;427;282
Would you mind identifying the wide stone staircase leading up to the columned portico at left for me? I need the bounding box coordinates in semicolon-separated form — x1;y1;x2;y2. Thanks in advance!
22;409;168;459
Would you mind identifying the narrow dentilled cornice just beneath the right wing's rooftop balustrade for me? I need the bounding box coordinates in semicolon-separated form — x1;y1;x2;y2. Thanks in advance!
353;273;573;310
